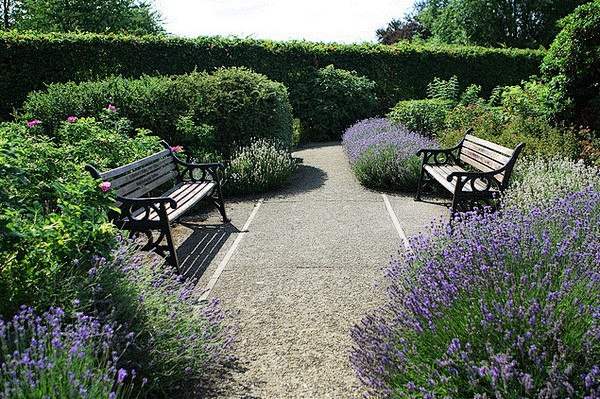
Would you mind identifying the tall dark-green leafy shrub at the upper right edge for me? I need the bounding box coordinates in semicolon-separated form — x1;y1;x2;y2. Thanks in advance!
541;0;600;126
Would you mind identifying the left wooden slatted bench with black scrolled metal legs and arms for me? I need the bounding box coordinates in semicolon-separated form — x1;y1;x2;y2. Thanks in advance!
86;142;229;273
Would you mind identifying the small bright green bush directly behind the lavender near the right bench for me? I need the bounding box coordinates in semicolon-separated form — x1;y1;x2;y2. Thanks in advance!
388;99;456;137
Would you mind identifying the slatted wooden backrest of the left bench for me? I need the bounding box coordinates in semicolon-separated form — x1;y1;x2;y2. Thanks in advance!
91;149;179;198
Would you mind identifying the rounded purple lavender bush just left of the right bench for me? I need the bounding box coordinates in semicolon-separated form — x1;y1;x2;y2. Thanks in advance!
342;118;438;191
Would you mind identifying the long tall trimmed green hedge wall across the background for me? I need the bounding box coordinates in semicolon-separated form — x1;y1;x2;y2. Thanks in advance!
0;32;544;118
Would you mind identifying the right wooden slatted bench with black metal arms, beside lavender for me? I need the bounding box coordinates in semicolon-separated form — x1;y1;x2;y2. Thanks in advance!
415;129;525;212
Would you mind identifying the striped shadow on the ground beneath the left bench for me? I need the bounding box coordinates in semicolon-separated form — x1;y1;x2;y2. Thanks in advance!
177;221;240;279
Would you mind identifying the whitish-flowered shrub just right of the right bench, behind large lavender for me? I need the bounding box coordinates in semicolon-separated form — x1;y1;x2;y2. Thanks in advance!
503;156;600;210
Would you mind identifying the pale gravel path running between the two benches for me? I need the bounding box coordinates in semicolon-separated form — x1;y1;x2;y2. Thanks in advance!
175;143;447;399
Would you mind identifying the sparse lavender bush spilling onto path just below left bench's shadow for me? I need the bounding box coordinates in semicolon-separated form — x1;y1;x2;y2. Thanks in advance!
79;239;233;397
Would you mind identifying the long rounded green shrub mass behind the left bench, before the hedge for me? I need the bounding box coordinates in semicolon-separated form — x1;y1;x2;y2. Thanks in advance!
17;68;292;158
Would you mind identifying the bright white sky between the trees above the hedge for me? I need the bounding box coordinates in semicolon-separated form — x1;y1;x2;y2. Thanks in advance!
154;0;414;43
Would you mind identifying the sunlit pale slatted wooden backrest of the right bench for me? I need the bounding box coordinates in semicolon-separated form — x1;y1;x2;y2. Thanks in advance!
460;134;515;183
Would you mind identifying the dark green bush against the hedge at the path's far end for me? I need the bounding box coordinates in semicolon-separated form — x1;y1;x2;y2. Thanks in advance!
291;65;377;141
